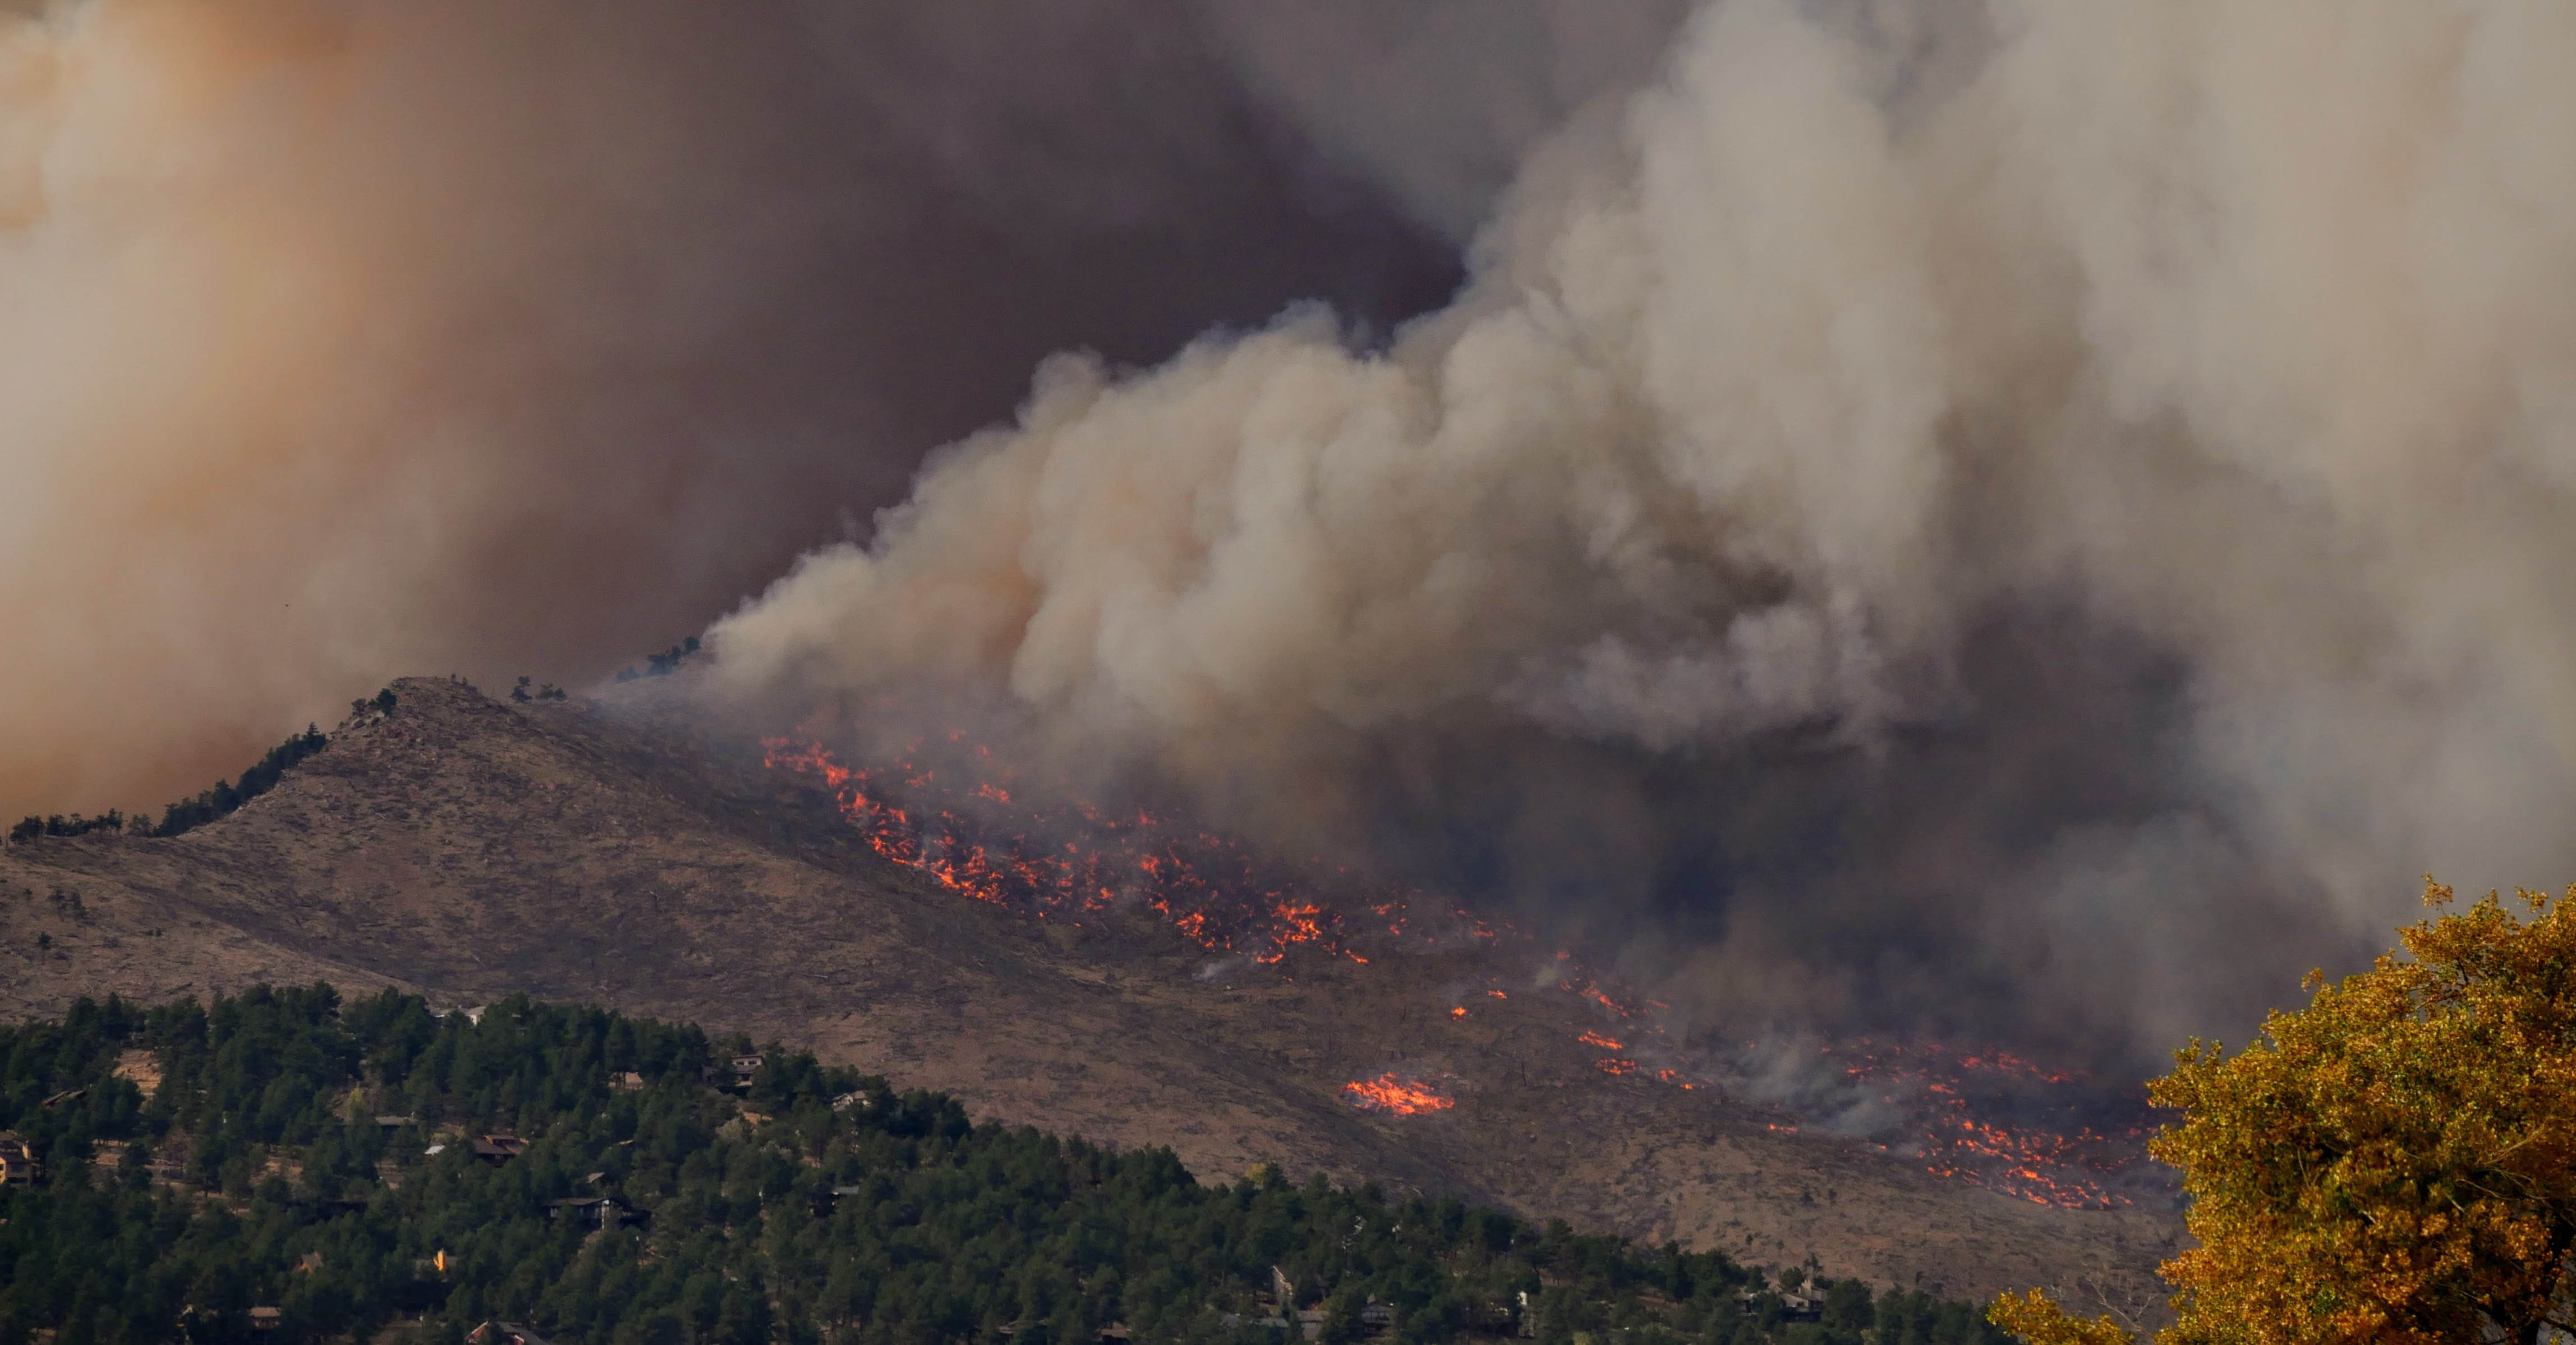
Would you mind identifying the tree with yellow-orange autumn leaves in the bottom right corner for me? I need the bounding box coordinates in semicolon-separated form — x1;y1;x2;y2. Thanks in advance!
1986;879;2576;1345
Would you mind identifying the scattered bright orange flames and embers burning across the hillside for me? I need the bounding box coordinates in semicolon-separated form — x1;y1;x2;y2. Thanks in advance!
765;734;2164;1209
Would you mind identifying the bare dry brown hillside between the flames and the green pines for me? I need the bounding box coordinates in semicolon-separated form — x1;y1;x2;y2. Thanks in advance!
0;680;2177;1311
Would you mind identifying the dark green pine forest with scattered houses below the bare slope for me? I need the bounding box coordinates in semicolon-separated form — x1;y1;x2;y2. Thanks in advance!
0;984;2009;1345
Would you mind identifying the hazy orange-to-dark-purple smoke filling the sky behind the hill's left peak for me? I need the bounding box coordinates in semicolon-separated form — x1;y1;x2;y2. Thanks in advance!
0;0;1677;817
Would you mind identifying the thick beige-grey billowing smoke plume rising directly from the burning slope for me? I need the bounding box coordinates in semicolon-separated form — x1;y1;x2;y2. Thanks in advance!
714;0;2576;1049
